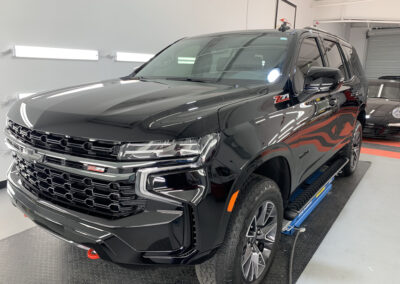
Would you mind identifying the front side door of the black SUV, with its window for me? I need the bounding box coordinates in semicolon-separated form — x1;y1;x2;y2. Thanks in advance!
285;37;337;183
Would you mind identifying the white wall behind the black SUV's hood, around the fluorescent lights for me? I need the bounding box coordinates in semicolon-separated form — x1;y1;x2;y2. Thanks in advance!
0;0;313;180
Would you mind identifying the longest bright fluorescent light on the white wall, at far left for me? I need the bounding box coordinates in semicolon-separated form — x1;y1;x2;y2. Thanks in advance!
14;45;99;60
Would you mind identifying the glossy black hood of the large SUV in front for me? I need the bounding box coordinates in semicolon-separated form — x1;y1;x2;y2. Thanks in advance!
8;79;262;142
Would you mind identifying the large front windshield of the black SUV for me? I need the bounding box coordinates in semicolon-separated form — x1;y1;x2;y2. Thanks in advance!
134;32;291;83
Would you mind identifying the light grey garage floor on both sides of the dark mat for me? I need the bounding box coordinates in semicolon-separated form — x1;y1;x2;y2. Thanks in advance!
0;154;400;283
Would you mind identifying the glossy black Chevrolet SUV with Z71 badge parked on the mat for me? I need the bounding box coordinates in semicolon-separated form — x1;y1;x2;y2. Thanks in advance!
6;28;367;283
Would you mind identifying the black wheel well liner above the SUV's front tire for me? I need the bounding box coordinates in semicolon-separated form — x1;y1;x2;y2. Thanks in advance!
254;156;291;207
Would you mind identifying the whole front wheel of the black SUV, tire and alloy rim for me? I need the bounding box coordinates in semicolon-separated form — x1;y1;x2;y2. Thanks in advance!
196;175;283;284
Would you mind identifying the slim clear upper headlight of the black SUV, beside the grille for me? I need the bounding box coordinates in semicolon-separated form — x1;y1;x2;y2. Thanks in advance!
118;133;219;160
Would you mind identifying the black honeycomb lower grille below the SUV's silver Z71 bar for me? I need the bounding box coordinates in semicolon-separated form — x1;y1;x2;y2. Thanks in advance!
14;155;145;219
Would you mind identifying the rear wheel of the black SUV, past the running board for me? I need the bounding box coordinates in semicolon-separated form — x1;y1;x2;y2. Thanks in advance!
342;120;362;177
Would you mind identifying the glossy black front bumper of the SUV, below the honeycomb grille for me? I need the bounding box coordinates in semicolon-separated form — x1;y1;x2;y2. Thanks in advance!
7;166;199;264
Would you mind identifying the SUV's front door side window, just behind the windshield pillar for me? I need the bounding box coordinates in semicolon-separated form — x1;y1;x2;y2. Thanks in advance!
294;38;324;92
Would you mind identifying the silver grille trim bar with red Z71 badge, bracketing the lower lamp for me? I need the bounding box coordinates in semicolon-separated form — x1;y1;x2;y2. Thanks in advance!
5;124;202;215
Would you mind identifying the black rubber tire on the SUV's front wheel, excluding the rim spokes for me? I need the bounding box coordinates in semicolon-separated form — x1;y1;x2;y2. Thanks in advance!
196;175;283;284
